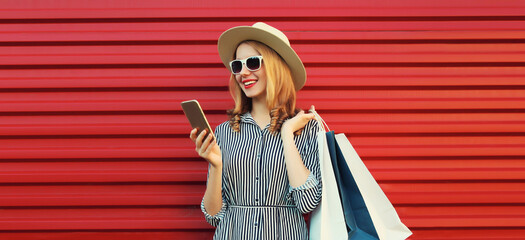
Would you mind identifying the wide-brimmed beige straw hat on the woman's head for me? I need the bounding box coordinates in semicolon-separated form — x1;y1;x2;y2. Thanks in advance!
218;22;306;91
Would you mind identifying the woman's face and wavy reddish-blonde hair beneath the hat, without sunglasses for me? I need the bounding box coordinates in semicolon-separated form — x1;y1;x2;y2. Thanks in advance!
228;40;297;133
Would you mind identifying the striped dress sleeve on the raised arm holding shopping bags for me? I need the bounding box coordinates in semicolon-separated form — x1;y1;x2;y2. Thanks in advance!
289;120;322;213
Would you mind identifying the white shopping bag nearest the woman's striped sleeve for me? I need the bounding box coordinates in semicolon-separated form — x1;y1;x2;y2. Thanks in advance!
310;113;348;240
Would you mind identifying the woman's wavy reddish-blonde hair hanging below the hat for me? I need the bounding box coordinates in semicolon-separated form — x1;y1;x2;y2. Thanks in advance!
228;41;301;135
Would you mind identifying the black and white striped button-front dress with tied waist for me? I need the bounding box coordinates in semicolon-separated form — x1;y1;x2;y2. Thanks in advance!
201;112;321;240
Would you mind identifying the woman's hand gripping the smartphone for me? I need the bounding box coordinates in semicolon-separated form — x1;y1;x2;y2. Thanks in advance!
190;128;222;168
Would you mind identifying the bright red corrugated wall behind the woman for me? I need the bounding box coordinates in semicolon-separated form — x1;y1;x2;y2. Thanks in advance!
0;0;525;240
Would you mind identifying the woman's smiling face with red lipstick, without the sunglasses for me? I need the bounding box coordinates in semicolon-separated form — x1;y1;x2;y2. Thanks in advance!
235;43;266;99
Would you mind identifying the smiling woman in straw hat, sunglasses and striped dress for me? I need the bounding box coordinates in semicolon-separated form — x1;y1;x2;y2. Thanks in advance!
190;23;321;240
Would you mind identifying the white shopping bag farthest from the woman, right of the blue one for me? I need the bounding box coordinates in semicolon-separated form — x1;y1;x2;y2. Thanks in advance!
335;133;412;240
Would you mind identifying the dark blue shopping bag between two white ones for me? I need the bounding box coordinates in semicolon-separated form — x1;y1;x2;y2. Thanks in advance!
326;131;379;240
